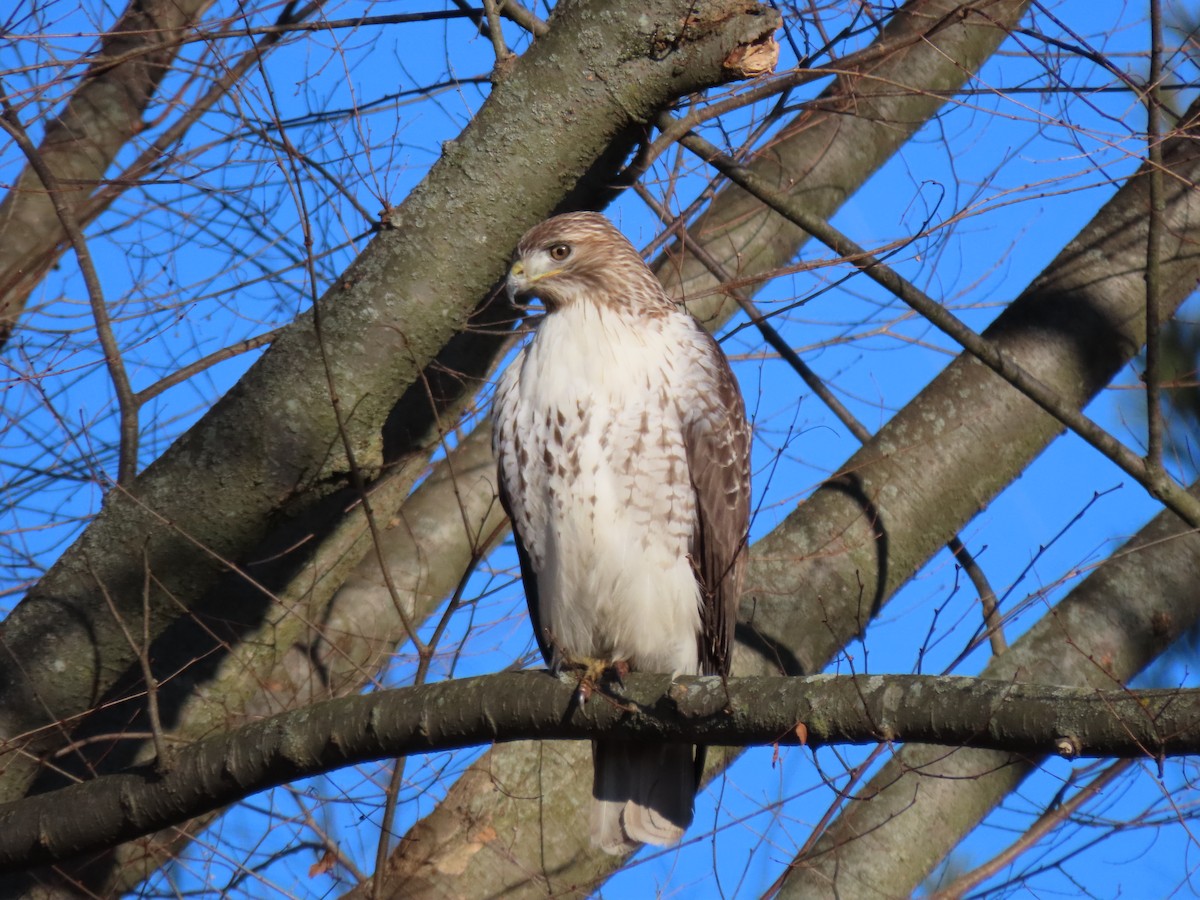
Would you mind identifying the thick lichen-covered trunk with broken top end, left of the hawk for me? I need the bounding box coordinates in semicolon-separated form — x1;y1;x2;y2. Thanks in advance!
0;0;778;811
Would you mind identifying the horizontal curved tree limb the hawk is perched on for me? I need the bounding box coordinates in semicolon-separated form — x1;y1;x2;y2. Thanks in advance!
7;672;1200;872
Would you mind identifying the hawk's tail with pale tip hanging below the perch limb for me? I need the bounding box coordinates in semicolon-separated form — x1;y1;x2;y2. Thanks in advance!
592;740;697;853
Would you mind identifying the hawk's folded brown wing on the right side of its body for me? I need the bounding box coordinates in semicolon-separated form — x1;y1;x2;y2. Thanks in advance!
684;332;750;676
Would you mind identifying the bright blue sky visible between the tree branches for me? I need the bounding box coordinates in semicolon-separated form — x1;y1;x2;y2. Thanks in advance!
0;0;1196;898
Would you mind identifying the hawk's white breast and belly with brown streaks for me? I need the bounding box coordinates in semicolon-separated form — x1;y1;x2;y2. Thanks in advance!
497;302;708;673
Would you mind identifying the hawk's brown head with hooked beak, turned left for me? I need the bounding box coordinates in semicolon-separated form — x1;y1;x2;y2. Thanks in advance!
508;212;671;312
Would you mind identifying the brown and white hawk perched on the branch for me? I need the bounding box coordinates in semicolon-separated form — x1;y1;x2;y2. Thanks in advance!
493;212;750;853
